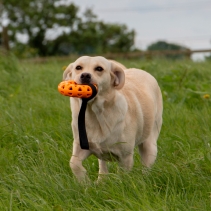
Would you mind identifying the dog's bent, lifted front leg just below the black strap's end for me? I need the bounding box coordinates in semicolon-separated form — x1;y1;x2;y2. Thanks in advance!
70;141;91;182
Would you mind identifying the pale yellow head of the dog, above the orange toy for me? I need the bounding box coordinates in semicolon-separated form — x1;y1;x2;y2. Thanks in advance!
63;56;125;93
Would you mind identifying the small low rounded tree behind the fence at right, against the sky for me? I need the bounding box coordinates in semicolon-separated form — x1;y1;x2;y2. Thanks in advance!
147;41;190;59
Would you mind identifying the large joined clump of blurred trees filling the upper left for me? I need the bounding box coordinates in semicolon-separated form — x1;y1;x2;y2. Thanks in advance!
2;0;135;56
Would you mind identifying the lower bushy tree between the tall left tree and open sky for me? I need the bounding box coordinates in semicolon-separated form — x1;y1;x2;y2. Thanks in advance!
47;9;135;54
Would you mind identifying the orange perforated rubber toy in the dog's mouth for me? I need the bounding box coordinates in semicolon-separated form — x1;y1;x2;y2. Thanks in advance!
58;81;97;98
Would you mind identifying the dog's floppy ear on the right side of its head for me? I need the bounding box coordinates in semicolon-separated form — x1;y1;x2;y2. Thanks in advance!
110;61;125;89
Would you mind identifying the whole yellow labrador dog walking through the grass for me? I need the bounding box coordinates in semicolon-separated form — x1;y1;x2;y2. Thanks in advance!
63;56;163;181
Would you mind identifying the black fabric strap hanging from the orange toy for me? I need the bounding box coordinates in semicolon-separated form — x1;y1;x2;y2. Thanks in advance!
78;84;97;150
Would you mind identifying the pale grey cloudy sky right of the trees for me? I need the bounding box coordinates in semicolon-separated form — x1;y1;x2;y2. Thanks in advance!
67;0;211;60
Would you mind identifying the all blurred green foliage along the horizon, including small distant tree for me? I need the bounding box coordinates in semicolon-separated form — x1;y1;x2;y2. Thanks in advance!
0;0;199;59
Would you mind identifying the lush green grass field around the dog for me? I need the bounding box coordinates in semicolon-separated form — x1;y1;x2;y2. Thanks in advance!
0;57;211;211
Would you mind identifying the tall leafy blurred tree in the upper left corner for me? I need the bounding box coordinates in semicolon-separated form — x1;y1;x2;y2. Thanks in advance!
2;0;79;56
